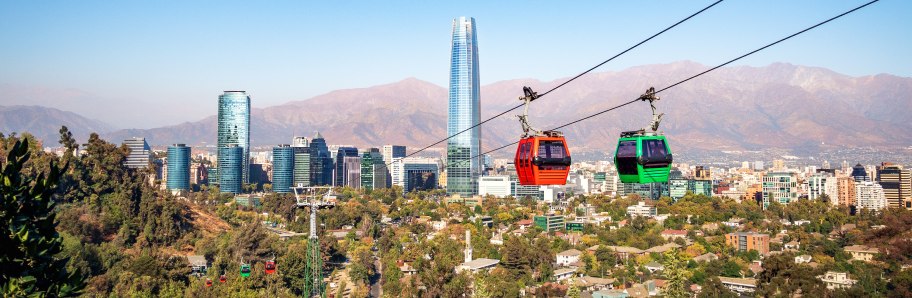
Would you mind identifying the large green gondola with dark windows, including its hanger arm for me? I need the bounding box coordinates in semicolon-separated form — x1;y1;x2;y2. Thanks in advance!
614;88;672;183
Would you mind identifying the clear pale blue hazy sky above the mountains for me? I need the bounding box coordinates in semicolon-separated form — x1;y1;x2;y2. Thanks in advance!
0;0;912;128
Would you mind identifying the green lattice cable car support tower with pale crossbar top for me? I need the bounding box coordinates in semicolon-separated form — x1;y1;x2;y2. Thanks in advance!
292;184;336;297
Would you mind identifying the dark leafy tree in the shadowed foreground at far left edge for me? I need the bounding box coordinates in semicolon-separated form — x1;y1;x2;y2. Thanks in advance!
0;138;83;297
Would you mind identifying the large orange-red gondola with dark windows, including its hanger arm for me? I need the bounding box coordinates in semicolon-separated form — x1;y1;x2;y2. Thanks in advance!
513;87;571;185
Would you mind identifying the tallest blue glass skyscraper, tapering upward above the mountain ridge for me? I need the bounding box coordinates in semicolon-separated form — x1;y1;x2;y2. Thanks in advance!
446;17;482;196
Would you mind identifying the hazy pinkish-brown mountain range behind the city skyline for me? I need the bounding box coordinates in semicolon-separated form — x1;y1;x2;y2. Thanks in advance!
0;61;912;154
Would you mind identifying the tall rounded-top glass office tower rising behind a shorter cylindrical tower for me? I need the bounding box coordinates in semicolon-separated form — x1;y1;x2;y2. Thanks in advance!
218;91;250;183
